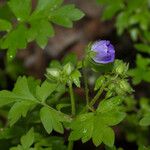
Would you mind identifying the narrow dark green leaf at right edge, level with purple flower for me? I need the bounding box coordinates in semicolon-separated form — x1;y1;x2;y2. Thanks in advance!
134;43;150;54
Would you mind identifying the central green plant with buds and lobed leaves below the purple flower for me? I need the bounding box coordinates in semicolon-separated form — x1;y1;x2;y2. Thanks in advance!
0;42;132;150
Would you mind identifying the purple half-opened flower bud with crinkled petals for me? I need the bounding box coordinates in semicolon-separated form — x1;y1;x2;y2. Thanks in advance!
91;40;115;64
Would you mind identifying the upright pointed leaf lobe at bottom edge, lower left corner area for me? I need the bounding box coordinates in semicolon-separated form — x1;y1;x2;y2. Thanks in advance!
21;128;34;149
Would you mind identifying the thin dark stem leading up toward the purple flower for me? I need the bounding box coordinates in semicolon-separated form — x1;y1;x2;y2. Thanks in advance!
82;60;89;106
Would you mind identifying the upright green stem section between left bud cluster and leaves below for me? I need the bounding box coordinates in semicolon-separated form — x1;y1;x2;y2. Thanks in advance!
69;82;76;116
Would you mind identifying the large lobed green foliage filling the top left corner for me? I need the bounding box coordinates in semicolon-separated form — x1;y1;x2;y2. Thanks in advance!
0;0;84;61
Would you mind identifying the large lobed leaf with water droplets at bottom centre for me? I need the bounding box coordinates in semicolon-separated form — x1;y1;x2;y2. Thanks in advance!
69;110;125;147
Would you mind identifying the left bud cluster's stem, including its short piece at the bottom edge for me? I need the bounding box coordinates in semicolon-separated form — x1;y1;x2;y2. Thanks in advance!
68;82;76;150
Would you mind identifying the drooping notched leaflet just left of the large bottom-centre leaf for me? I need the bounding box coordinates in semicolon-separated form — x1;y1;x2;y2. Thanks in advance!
40;107;64;134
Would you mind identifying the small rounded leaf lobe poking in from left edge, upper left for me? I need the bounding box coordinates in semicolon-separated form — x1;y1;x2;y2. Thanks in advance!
0;19;12;32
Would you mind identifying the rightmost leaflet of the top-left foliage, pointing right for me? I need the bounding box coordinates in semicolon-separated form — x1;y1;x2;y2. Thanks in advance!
49;4;84;28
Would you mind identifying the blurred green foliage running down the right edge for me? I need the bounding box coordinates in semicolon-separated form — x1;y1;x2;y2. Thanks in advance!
97;0;150;150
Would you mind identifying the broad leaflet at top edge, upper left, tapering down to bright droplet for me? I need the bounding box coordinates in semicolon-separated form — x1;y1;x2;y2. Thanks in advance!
8;0;31;21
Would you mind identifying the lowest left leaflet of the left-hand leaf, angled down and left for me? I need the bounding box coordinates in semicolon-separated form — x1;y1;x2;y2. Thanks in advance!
8;101;35;126
